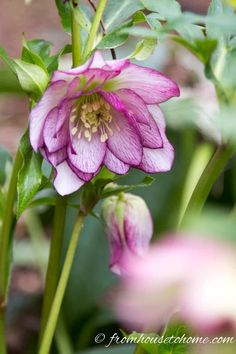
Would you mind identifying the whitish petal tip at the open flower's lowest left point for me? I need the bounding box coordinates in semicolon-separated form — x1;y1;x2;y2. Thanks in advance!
54;161;84;195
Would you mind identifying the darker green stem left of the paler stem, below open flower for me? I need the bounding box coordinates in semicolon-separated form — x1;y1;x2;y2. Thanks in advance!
40;195;67;338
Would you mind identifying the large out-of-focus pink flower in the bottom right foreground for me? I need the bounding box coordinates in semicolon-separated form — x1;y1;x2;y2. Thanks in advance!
114;235;236;334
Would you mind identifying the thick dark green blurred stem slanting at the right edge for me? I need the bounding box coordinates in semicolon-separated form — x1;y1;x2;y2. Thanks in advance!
180;146;234;225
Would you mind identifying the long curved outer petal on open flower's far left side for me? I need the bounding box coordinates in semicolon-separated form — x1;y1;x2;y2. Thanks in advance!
29;81;67;151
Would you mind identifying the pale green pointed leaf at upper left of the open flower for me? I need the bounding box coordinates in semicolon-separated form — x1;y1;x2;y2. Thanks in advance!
14;59;49;99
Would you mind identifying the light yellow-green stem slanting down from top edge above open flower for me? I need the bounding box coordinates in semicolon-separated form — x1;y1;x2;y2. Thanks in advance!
83;0;107;59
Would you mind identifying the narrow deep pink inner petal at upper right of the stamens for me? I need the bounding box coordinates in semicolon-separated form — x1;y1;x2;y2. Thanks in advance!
116;89;150;124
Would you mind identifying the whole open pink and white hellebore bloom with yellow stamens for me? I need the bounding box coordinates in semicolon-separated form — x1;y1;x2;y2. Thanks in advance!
30;52;179;195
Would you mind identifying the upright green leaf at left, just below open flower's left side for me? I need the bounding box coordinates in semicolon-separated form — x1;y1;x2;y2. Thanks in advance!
16;132;43;218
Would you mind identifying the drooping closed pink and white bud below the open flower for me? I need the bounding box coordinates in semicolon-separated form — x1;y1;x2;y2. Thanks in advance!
102;193;153;274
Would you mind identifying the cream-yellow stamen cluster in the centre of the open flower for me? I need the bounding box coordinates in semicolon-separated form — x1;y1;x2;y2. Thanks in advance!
70;94;113;143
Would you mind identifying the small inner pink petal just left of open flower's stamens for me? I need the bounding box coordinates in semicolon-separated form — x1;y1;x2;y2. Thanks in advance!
43;107;69;153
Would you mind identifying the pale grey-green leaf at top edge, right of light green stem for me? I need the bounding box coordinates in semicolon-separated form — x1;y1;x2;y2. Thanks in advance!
103;0;144;30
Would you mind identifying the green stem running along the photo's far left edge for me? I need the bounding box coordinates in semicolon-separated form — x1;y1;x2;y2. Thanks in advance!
0;150;23;354
